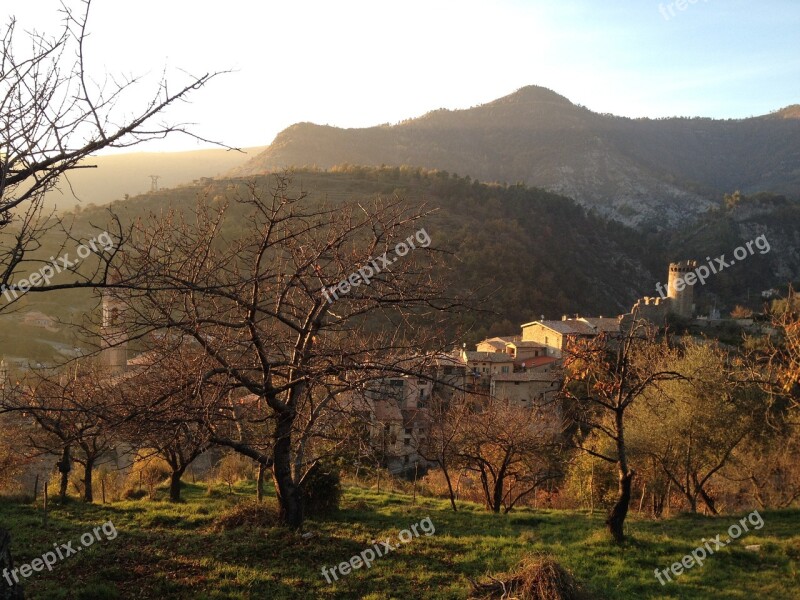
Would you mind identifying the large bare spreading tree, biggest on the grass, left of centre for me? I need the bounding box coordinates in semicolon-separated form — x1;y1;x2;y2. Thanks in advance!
113;176;460;528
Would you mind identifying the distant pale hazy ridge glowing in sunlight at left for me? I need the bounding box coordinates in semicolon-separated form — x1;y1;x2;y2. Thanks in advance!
45;146;264;211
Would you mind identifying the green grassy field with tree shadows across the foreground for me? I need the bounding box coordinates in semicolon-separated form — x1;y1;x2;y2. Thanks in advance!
0;483;800;600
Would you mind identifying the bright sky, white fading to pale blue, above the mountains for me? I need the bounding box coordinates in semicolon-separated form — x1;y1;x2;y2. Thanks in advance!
0;0;800;150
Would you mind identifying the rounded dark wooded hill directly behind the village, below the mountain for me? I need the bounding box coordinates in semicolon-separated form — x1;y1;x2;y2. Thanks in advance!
0;167;659;362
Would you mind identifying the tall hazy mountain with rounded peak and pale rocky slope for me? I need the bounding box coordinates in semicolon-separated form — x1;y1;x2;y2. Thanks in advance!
233;86;800;230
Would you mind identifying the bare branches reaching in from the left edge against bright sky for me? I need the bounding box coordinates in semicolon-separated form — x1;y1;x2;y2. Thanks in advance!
0;0;225;302
